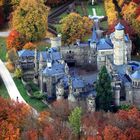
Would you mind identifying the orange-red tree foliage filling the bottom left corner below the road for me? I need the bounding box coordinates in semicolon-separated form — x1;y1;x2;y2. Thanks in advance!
0;98;29;140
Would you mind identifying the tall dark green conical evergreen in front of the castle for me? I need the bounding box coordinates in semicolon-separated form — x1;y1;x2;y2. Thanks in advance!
96;66;112;111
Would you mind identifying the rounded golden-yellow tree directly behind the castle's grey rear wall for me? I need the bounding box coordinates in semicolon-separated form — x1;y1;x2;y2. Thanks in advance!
60;13;93;44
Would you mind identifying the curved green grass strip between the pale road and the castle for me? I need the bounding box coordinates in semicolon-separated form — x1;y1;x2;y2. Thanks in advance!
14;78;48;112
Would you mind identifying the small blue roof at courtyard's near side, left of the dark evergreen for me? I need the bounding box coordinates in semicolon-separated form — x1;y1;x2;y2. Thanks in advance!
72;77;85;89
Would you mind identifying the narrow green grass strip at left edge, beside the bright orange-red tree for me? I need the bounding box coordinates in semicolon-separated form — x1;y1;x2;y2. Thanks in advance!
0;37;6;61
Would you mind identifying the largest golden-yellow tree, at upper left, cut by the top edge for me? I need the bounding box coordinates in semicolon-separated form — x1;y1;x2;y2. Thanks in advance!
11;0;48;41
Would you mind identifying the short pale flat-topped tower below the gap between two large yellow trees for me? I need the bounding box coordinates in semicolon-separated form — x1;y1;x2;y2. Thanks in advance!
50;34;61;49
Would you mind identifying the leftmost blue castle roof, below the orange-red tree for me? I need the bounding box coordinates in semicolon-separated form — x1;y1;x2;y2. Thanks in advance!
18;50;34;57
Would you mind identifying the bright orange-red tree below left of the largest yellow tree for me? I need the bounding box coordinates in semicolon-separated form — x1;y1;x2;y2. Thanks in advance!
6;30;25;50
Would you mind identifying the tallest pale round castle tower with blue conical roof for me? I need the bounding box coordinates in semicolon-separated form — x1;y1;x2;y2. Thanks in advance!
112;23;127;65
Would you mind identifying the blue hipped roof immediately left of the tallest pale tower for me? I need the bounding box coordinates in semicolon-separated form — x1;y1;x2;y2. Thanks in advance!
97;38;113;50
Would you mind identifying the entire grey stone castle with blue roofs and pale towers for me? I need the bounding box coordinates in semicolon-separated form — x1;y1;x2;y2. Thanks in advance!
18;23;140;111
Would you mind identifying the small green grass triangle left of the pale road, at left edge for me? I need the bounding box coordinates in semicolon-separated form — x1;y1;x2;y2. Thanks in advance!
0;79;10;99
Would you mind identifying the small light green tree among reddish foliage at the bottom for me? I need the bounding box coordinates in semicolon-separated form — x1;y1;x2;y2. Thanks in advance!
68;107;82;135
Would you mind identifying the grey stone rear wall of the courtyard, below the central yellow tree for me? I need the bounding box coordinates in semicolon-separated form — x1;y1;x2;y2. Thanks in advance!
60;45;96;66
